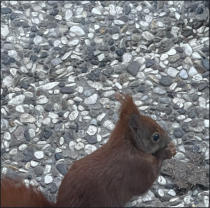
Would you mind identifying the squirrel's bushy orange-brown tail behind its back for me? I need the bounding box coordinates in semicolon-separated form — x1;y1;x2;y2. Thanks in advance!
1;177;53;207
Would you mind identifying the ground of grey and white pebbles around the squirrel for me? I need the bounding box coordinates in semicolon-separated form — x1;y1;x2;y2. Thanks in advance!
1;1;209;207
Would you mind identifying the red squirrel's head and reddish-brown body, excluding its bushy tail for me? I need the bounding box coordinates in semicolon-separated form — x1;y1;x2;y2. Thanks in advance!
56;94;176;207
